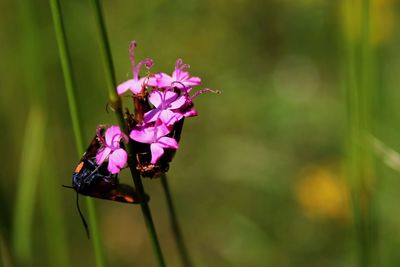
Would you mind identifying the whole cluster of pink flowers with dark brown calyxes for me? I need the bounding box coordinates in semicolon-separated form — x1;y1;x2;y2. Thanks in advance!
96;41;216;177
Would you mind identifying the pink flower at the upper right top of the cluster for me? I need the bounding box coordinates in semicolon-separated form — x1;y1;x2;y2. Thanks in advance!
155;59;201;91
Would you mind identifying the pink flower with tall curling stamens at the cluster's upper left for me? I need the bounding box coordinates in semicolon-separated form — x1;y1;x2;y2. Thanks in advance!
117;41;157;95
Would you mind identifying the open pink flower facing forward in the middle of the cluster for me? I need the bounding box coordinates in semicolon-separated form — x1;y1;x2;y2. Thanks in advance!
144;90;188;126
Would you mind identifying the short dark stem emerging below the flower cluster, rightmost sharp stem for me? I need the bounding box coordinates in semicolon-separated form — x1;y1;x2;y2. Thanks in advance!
160;174;192;267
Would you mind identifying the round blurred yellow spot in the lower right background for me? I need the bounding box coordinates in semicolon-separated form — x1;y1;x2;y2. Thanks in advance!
295;167;349;221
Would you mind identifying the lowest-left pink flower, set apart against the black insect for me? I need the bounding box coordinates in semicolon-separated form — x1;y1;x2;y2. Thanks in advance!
96;126;128;174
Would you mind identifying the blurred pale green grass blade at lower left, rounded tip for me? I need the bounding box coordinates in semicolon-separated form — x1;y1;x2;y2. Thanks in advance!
12;107;46;266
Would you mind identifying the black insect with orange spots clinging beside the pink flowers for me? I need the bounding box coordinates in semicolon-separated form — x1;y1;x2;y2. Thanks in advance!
64;127;148;237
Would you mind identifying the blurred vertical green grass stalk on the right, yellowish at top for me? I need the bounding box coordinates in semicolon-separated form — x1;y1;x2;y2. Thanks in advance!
344;0;376;267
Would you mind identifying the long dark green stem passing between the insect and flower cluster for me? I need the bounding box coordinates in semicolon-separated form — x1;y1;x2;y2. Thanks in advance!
92;0;165;267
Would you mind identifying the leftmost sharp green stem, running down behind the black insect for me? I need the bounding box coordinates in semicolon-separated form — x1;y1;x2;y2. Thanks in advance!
50;0;106;267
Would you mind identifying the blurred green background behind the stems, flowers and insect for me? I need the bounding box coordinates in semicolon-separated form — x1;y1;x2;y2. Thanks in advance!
0;0;400;267
